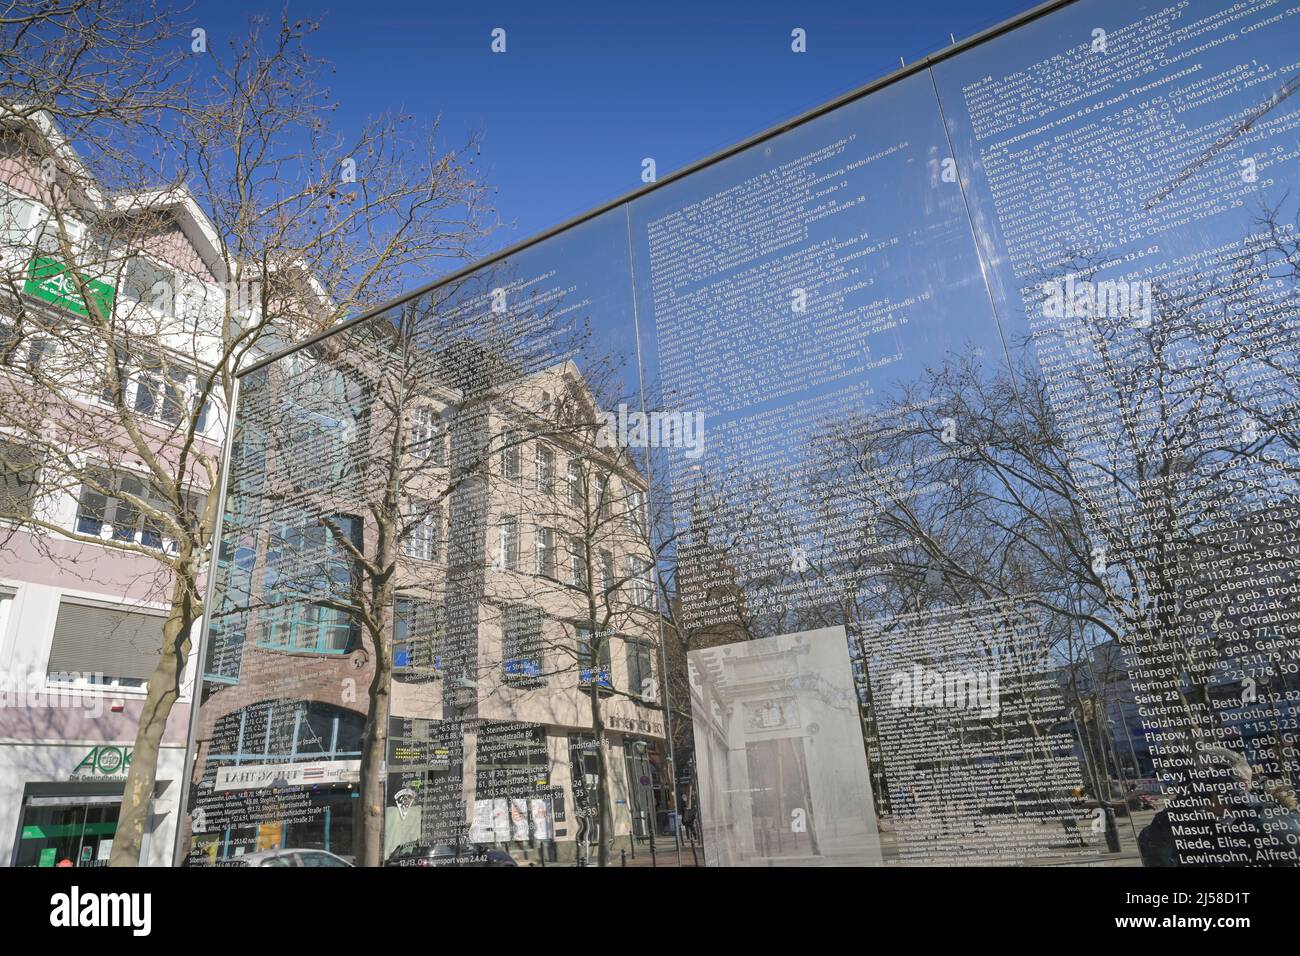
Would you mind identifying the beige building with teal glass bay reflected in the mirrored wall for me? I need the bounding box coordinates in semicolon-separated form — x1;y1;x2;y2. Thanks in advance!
183;345;670;862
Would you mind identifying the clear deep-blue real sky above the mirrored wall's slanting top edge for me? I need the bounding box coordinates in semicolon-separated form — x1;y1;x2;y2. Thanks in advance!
190;0;1036;269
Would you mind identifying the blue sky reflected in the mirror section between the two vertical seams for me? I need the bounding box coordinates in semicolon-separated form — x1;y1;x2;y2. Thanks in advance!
632;74;1002;538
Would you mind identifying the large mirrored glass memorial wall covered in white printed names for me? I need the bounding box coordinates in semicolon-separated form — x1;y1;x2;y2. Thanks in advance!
178;0;1300;866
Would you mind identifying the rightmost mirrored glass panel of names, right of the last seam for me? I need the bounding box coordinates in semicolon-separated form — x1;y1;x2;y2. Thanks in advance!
932;0;1300;865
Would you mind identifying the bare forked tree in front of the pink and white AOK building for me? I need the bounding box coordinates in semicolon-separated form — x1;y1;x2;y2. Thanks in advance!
0;11;482;865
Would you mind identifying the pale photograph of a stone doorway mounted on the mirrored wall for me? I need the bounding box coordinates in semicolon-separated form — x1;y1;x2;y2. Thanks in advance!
690;627;880;866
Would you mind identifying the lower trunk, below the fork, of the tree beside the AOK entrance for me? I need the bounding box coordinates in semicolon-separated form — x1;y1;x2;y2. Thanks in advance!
108;574;203;866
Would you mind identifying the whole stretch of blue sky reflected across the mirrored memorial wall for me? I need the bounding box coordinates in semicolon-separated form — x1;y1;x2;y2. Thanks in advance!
210;3;1300;624
